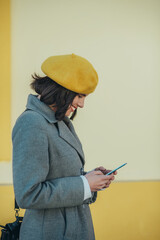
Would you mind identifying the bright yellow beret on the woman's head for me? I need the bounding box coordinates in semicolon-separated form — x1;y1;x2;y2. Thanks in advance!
41;54;98;94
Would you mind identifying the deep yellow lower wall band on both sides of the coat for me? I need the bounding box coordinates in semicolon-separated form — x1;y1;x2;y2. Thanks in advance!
0;182;160;240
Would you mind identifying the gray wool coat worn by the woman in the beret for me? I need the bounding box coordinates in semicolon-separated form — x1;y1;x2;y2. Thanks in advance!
12;95;96;240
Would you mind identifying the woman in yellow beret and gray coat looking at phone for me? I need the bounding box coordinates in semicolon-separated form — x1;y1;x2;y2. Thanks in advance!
12;54;114;240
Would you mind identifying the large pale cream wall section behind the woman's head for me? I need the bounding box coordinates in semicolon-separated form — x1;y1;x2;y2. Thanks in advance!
11;0;160;181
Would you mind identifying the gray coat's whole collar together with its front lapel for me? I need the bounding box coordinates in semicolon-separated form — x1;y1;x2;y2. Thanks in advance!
26;94;84;164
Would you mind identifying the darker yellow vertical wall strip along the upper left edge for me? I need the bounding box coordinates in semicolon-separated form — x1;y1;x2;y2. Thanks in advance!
0;0;11;161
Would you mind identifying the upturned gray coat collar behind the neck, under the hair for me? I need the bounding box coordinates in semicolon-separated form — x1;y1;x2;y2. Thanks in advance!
26;94;57;123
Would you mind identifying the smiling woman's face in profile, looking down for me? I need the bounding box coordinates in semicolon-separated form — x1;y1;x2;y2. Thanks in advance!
65;94;87;117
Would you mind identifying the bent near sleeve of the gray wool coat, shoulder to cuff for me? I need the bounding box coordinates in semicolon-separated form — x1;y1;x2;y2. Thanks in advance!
12;121;84;209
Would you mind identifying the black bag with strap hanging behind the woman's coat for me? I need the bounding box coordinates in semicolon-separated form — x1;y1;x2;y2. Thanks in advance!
0;200;23;240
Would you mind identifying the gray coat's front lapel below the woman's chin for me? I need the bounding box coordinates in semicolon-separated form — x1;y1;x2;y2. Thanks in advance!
58;121;85;165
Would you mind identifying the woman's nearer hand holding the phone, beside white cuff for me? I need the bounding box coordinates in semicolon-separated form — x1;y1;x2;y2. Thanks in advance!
84;170;114;192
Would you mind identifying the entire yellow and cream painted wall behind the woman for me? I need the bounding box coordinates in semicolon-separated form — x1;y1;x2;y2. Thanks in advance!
0;0;160;240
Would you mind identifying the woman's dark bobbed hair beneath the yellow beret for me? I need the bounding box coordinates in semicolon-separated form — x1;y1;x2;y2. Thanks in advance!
30;73;78;121
